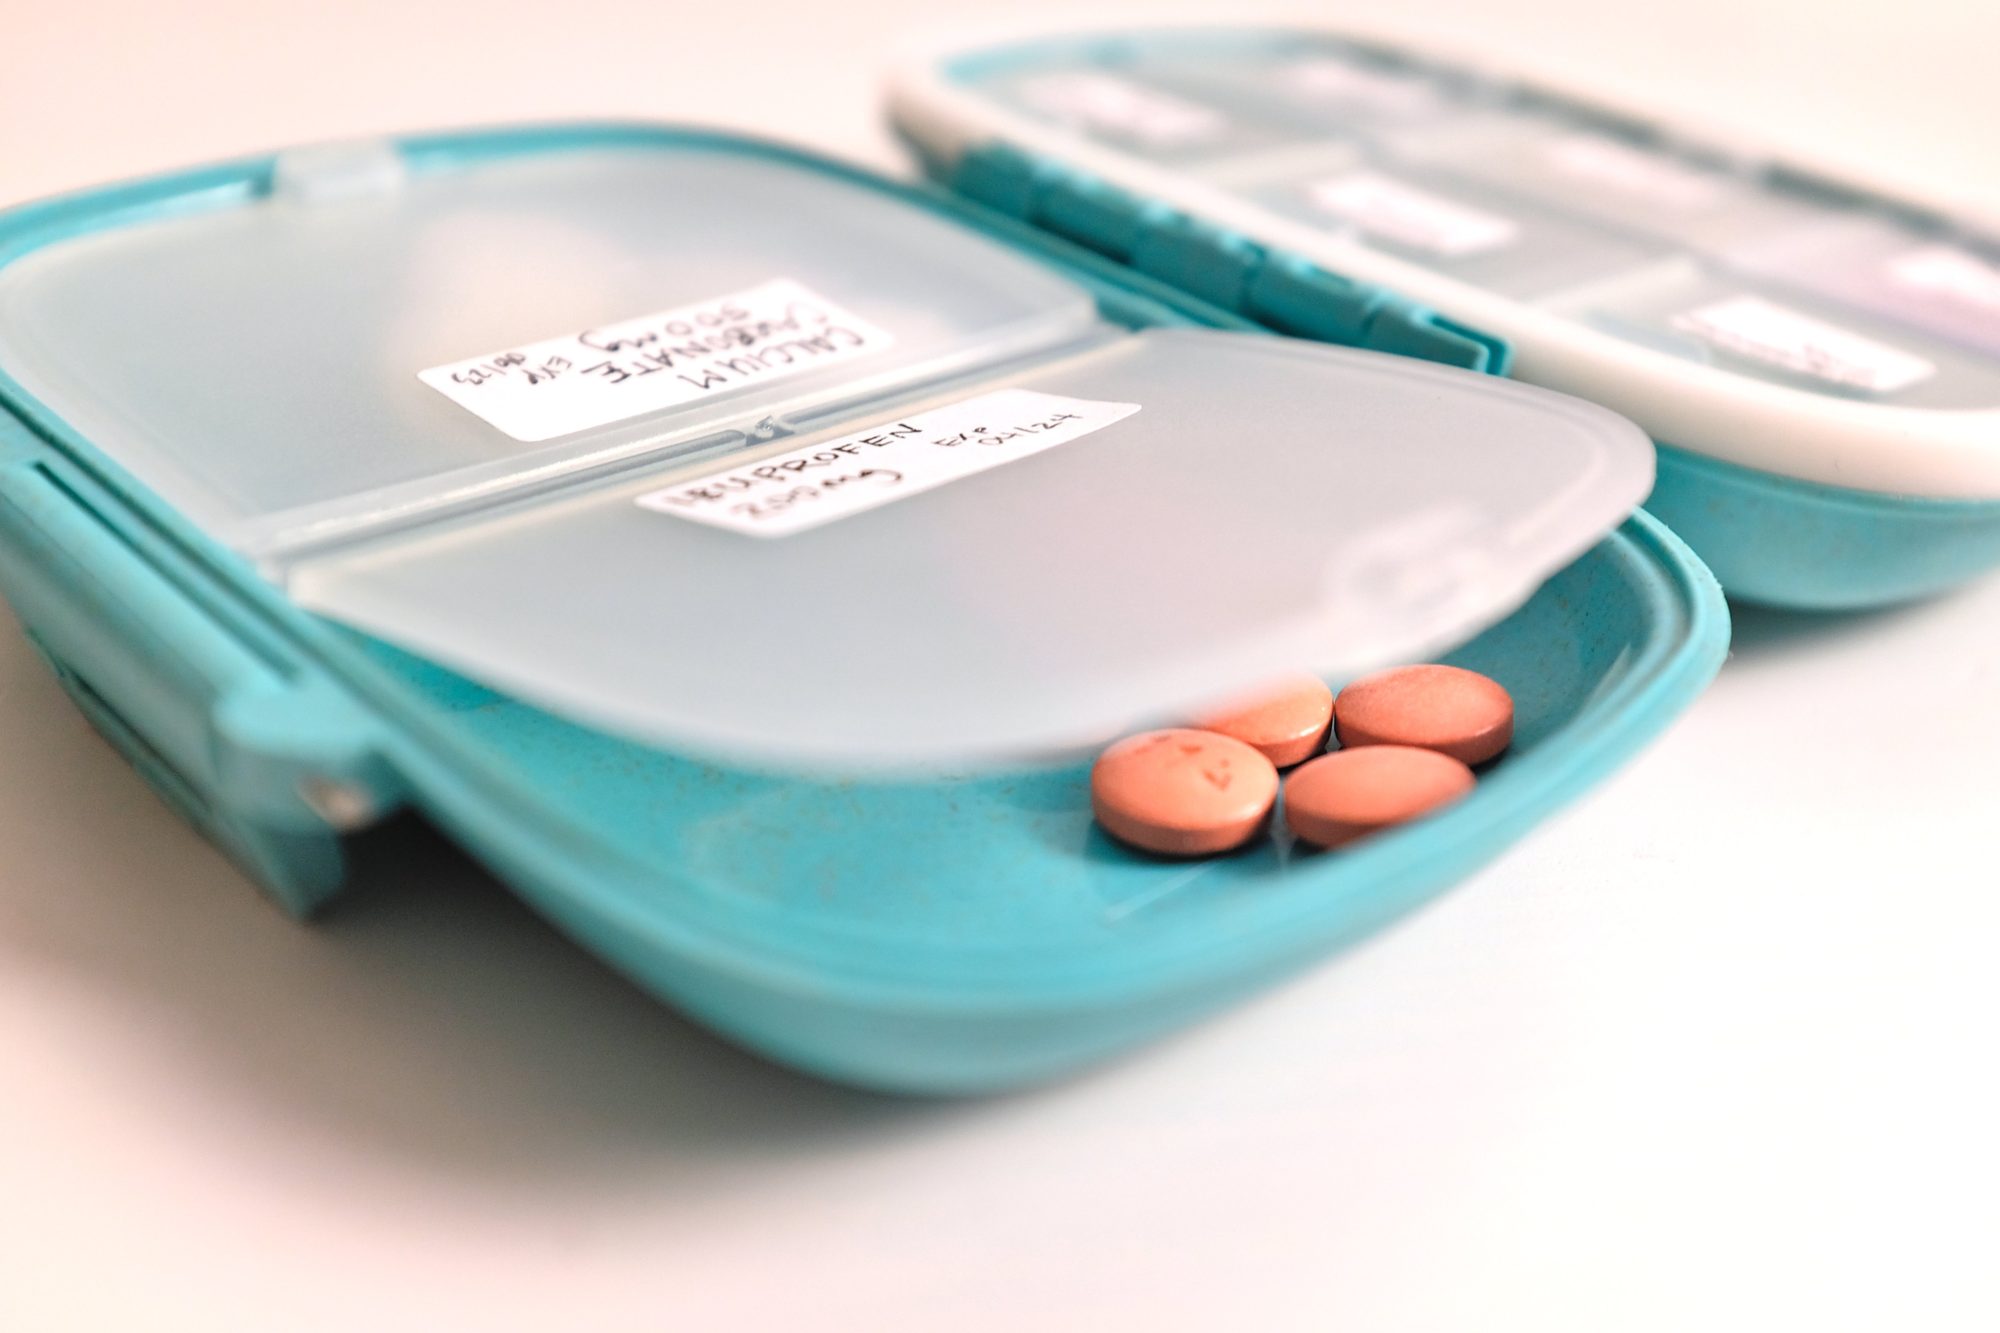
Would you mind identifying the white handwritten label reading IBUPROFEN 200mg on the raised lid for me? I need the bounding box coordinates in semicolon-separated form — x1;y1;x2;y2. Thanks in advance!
638;388;1138;536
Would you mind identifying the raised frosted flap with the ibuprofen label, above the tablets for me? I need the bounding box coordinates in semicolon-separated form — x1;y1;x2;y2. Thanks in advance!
290;330;1652;769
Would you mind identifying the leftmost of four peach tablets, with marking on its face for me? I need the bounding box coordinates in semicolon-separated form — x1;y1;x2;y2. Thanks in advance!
1090;729;1278;857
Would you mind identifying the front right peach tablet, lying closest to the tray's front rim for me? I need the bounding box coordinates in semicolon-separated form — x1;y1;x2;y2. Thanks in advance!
1284;745;1478;847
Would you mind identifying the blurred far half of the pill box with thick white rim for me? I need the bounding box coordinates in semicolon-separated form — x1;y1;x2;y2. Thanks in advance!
892;26;2000;610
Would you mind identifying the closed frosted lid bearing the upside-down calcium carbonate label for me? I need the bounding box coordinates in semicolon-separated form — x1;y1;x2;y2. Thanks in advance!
0;134;1096;548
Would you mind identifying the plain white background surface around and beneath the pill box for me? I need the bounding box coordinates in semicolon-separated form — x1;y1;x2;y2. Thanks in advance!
0;0;2000;1333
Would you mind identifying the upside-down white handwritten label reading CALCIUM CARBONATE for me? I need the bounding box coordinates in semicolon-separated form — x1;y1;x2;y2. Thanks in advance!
416;278;894;442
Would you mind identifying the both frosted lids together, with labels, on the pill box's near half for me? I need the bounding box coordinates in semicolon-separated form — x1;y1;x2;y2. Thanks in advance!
0;131;1652;769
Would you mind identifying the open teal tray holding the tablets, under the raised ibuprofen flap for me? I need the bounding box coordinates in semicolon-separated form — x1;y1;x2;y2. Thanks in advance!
336;516;1728;1093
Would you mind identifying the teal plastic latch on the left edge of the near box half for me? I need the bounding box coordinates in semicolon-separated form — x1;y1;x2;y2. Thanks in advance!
0;446;400;913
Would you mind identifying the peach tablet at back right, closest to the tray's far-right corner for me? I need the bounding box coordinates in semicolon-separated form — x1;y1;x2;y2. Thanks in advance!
1334;667;1514;765
